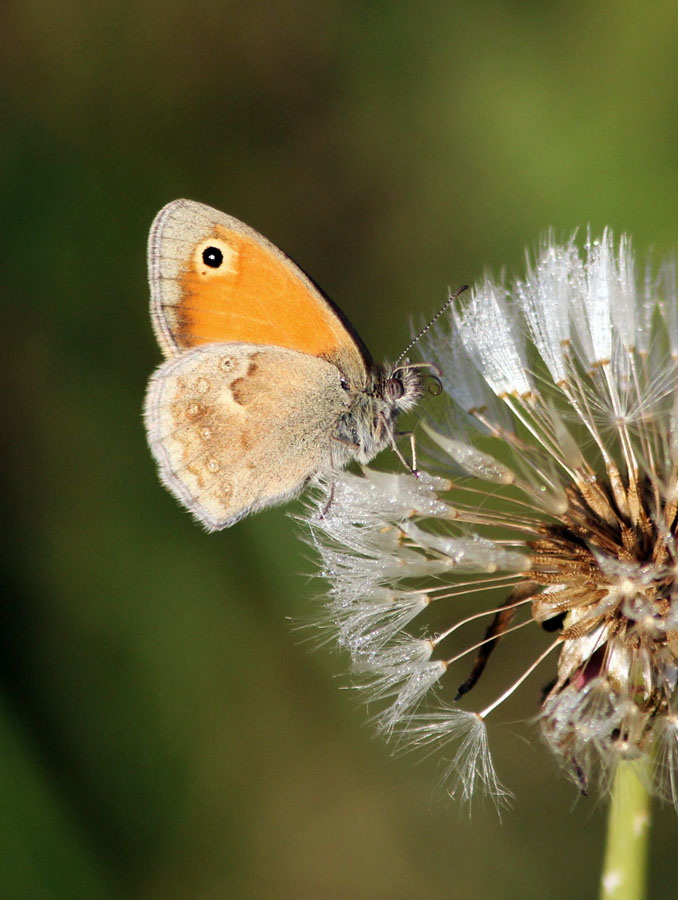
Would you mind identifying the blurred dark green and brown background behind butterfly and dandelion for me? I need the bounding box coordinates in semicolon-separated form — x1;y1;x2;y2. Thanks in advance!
0;0;678;900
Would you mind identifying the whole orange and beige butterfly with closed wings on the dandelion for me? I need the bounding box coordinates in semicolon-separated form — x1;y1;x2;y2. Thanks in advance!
144;200;432;531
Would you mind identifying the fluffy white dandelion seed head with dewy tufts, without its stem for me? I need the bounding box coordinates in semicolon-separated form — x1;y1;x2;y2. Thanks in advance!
307;231;678;806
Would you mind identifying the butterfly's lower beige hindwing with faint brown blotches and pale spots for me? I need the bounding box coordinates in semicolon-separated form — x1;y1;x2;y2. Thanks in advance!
145;344;349;530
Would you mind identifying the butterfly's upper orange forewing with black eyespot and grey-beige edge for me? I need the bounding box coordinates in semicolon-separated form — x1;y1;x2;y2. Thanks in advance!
148;200;371;388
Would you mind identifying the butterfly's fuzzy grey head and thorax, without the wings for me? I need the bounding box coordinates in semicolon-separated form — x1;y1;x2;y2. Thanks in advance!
333;364;424;463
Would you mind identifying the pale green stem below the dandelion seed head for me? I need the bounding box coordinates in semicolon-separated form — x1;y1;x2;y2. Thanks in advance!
600;762;650;900
